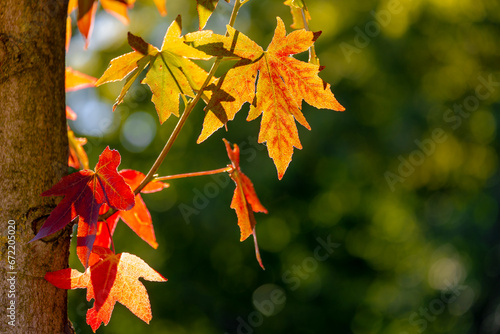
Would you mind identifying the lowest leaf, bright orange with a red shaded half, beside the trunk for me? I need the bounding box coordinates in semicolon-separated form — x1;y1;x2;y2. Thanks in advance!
45;247;167;332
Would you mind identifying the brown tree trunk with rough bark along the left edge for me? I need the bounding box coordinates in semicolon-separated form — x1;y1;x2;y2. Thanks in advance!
0;0;71;333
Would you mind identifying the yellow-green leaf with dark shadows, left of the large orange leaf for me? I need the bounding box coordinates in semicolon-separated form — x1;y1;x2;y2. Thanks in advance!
96;16;216;123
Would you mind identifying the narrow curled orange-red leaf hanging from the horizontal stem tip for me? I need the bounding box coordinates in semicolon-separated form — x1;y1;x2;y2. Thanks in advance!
223;139;267;269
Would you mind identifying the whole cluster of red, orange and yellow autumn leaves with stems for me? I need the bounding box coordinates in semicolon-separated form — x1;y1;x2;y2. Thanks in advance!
36;0;344;331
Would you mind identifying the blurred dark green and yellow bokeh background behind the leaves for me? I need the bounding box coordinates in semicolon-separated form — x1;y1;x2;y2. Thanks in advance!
67;0;500;334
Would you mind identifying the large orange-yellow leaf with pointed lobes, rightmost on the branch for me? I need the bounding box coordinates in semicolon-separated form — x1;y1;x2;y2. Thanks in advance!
198;17;344;179
